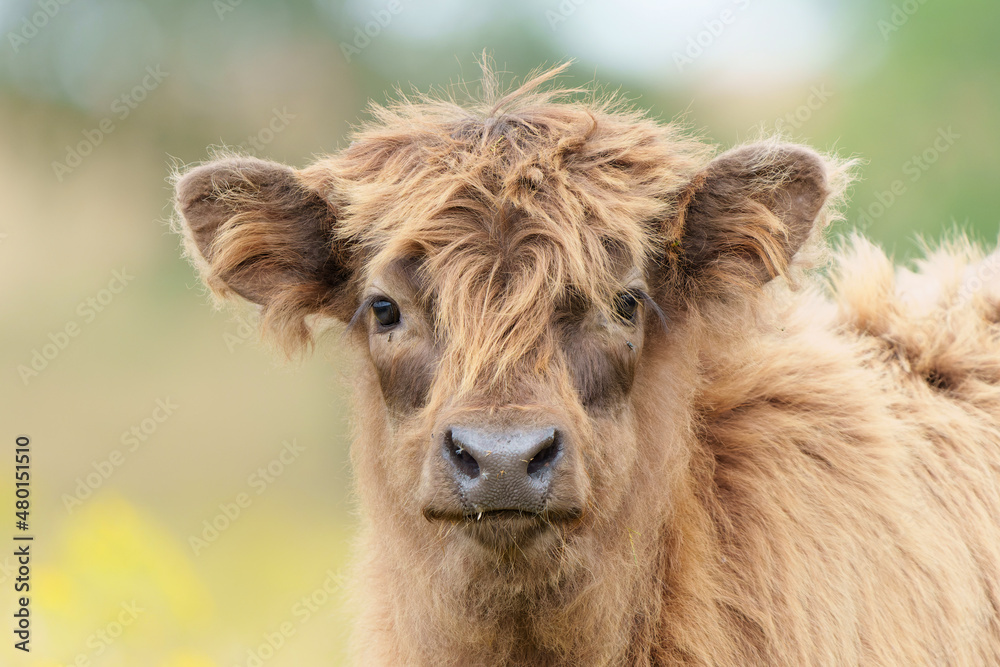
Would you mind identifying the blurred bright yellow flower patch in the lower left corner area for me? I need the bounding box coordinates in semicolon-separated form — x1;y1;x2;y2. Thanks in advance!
33;491;213;665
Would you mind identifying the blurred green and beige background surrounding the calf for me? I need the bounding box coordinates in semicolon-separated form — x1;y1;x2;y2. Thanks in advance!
0;0;1000;667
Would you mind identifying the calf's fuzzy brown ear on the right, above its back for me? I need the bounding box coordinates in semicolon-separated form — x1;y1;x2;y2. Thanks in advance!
664;143;830;296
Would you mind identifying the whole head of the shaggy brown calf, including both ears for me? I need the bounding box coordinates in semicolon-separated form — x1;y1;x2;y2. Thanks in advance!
177;72;827;648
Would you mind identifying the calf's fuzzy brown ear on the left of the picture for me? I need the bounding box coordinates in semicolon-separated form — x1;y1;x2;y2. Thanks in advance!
176;157;354;347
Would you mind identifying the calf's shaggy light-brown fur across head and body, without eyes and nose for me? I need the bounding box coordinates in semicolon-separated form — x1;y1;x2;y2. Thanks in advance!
177;64;1000;667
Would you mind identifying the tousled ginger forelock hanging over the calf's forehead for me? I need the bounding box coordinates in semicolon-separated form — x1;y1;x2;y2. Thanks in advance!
307;67;710;390
